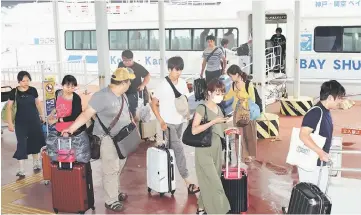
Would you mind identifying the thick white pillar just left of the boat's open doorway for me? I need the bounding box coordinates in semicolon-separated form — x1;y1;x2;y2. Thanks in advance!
252;0;266;112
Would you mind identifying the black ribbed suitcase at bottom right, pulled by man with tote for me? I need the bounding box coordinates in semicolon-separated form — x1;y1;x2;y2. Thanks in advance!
287;162;332;214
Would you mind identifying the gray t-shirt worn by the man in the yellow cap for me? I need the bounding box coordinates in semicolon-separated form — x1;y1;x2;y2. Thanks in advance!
88;87;131;136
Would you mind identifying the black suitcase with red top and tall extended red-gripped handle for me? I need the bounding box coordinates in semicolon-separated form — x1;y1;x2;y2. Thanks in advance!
221;128;249;214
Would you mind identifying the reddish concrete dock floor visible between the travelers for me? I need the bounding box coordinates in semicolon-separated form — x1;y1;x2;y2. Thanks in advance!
1;98;361;214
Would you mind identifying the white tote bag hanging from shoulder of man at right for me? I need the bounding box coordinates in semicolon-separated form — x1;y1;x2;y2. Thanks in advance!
286;106;326;171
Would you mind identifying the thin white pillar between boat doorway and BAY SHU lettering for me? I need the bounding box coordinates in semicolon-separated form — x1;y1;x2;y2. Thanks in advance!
293;0;301;99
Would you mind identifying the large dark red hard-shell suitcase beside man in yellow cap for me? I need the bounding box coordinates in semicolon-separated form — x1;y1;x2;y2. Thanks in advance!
51;162;95;214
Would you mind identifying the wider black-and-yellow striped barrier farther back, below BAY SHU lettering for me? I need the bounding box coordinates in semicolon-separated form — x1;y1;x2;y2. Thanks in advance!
280;96;313;116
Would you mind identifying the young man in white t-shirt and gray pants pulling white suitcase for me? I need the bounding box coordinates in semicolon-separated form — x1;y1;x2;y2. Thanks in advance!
152;57;199;194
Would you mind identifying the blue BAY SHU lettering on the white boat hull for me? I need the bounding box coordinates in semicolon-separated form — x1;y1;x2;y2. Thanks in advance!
300;59;361;71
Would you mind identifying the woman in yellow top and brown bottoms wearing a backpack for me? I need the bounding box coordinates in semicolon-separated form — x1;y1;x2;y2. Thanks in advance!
224;65;262;163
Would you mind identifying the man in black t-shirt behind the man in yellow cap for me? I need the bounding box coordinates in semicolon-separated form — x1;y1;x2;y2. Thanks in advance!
118;50;150;116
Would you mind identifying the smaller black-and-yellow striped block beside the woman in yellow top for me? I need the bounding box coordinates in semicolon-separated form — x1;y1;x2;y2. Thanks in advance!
257;113;280;139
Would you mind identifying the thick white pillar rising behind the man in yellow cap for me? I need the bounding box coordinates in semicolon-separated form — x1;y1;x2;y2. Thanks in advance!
94;1;111;88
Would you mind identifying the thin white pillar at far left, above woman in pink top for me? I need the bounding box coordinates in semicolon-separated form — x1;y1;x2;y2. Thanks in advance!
51;0;64;83
